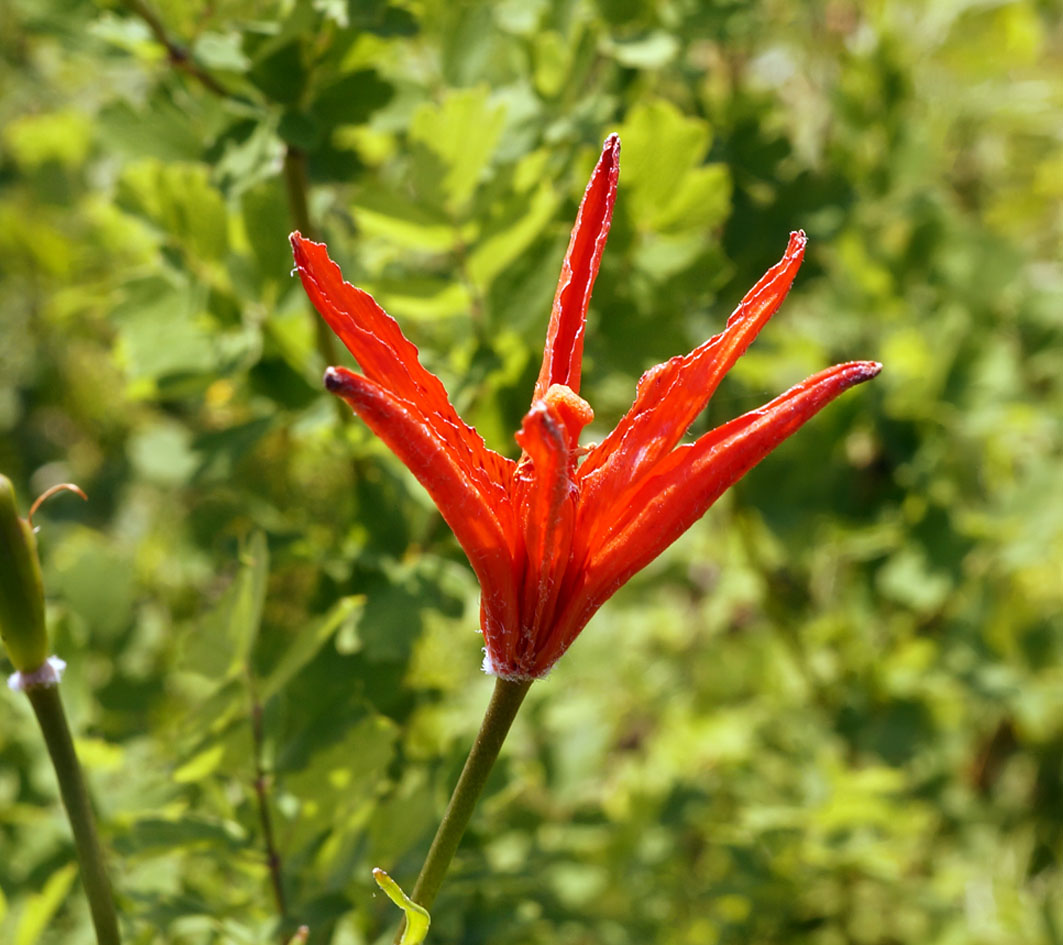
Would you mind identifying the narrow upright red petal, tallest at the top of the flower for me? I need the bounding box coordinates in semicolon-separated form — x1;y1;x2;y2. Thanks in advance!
533;135;620;401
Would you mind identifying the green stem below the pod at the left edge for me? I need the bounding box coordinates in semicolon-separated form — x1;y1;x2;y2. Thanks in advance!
26;686;121;945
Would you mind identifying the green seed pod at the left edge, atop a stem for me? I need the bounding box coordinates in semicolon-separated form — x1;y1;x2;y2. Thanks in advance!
0;475;48;673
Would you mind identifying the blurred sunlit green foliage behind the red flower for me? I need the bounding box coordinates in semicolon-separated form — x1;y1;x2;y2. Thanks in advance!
0;0;1063;945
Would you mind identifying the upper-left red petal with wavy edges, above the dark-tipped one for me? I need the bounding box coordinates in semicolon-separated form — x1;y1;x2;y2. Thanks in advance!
291;233;513;495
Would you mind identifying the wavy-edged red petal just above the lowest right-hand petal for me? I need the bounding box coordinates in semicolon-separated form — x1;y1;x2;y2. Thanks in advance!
579;231;807;493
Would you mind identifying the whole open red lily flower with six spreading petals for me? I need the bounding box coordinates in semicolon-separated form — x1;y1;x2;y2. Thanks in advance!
291;135;881;679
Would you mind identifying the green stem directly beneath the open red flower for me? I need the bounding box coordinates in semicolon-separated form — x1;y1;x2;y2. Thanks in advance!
395;678;533;943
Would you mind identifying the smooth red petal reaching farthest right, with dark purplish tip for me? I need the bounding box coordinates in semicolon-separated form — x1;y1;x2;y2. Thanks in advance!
555;361;882;646
